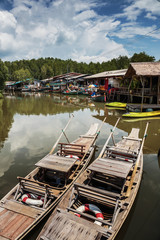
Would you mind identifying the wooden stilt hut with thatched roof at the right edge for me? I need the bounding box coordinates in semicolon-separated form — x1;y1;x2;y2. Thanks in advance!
117;62;160;104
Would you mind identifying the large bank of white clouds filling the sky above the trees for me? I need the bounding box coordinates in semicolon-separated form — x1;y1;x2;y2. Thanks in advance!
0;0;160;62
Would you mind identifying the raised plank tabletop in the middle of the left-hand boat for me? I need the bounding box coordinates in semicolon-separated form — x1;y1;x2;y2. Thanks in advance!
35;155;77;173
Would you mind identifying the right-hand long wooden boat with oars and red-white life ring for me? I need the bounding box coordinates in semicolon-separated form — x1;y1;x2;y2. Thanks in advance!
37;118;148;240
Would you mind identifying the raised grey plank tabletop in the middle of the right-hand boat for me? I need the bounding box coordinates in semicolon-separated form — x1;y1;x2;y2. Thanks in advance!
88;158;132;178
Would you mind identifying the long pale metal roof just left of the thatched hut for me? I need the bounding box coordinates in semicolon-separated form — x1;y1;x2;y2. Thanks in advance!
84;69;127;79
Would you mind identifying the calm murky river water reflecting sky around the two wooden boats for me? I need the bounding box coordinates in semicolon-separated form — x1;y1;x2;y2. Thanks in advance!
0;93;160;240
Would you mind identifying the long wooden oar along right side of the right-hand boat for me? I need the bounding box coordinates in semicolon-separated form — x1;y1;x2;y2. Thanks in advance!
125;122;149;197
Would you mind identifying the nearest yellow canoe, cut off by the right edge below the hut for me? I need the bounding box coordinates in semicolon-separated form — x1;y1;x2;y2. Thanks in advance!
122;111;160;118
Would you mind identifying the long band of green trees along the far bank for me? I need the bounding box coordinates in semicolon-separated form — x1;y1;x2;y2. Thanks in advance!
0;52;155;90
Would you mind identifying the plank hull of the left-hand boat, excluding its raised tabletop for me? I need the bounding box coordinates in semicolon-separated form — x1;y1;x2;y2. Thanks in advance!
0;124;98;240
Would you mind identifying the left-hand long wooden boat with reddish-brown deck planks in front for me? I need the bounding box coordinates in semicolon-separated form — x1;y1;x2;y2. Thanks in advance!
0;116;102;240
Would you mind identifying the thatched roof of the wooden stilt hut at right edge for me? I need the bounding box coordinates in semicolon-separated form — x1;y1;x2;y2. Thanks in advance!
125;62;160;78
